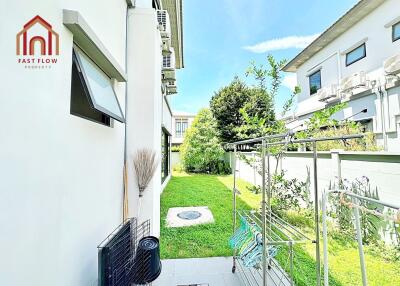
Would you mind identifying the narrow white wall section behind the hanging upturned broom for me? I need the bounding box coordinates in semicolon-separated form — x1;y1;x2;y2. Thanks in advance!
127;8;163;236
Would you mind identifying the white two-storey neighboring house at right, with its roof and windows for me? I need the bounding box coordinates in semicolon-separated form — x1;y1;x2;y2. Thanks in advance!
283;0;400;151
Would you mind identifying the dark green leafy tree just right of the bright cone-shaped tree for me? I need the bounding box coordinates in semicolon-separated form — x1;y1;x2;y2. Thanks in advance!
210;77;250;142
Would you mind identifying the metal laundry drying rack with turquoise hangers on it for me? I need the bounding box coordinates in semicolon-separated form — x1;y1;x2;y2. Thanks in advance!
230;132;363;286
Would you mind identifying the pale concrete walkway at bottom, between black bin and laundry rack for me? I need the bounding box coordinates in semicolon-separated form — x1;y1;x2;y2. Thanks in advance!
152;257;242;286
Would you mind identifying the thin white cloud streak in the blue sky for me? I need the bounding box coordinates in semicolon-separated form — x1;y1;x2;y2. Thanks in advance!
243;34;319;53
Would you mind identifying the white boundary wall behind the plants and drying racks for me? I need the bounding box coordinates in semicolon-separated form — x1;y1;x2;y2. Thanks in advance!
226;150;400;204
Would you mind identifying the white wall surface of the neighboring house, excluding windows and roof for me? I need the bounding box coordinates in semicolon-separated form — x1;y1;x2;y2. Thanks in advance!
290;0;400;152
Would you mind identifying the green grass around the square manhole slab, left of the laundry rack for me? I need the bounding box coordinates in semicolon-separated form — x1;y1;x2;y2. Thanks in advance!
161;173;249;258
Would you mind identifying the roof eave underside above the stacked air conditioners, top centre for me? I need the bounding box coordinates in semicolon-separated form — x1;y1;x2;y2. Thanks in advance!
161;0;184;69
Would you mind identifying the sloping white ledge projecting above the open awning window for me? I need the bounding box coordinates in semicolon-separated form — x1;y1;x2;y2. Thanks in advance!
63;10;127;82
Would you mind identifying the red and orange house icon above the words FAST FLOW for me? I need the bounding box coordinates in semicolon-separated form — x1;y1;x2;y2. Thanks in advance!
16;15;60;56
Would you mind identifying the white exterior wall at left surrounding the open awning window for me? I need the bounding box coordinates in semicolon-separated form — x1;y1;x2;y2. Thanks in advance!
0;0;126;286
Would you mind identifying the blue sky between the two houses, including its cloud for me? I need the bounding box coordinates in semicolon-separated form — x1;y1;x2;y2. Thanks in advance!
172;0;357;113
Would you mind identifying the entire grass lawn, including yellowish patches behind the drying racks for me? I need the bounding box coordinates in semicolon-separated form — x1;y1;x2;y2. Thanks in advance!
161;173;400;286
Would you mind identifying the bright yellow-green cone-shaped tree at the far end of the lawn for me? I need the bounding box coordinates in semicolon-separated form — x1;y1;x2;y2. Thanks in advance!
181;108;230;173
